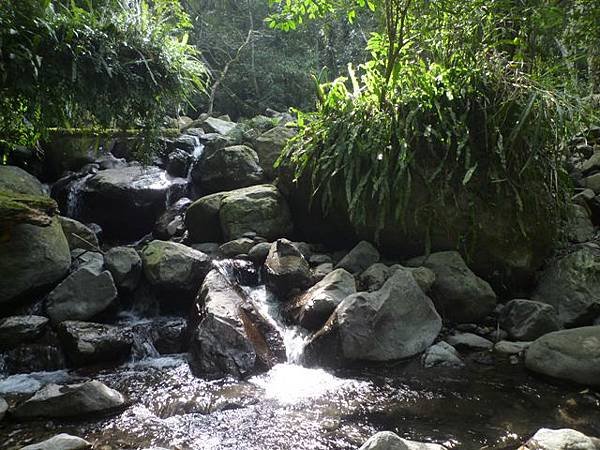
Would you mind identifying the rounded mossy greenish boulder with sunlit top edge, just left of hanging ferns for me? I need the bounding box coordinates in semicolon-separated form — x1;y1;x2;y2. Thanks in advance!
219;184;293;240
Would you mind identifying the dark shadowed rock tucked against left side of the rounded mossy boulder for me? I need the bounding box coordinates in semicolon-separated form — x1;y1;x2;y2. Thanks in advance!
185;192;227;242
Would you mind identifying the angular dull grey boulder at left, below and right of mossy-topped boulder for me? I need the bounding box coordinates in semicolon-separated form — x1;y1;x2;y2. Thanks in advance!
46;267;117;324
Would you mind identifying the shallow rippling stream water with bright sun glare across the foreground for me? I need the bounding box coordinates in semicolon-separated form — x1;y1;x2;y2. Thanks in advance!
0;355;600;450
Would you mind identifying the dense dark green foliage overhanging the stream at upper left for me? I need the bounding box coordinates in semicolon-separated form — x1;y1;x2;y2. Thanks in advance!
0;0;206;155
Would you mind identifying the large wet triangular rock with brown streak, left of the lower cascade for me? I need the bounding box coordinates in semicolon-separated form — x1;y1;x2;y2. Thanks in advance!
190;270;285;378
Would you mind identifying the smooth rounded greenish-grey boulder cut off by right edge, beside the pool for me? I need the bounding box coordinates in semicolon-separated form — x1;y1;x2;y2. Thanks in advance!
525;326;600;386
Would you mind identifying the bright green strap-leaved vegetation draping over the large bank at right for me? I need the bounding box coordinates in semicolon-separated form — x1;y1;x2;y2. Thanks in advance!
271;0;600;241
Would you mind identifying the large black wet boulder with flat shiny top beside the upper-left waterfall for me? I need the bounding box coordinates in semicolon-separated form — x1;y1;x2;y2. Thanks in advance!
80;166;171;239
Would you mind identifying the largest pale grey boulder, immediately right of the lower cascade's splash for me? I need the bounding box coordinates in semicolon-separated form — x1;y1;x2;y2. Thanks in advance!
305;271;442;366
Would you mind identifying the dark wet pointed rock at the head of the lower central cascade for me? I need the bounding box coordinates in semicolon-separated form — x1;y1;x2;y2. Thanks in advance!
264;239;312;300
